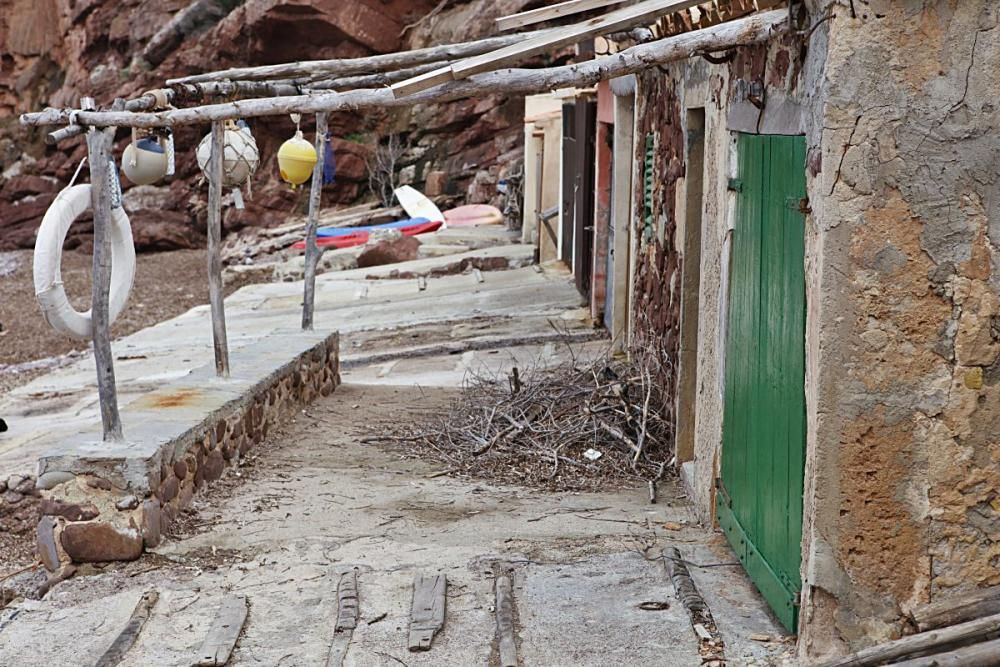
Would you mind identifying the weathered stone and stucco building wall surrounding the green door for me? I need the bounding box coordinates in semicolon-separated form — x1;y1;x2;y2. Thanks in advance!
633;0;1000;656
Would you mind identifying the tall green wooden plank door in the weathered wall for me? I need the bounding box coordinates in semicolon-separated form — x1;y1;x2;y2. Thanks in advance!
718;134;806;631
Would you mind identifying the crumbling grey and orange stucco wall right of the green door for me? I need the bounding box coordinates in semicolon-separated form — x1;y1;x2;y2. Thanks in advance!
800;0;1000;655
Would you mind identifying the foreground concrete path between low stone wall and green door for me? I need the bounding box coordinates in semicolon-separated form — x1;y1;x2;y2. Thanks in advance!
0;384;783;667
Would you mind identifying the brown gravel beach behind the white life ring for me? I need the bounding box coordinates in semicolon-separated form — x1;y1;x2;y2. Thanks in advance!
0;250;254;395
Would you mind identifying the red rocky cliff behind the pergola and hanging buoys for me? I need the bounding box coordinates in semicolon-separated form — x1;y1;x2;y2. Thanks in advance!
0;0;540;250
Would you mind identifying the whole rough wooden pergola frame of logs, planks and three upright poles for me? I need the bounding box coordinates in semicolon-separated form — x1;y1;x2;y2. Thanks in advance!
20;6;788;440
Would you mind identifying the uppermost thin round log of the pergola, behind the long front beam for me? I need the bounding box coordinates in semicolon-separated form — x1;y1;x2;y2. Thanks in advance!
167;30;551;87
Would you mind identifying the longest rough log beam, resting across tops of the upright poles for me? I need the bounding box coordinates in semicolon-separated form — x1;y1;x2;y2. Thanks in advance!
21;9;788;127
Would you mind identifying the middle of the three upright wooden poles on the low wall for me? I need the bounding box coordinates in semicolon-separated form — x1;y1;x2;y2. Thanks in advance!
208;122;229;377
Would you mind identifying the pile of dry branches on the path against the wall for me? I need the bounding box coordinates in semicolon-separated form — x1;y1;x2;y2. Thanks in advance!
376;357;673;491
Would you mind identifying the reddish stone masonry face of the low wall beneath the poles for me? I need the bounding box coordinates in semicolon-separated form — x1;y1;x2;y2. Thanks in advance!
38;335;340;571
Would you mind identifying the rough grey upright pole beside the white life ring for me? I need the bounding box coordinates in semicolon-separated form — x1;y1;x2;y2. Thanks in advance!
81;97;122;442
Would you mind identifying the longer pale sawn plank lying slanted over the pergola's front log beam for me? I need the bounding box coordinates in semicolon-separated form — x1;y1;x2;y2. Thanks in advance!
392;0;703;97
